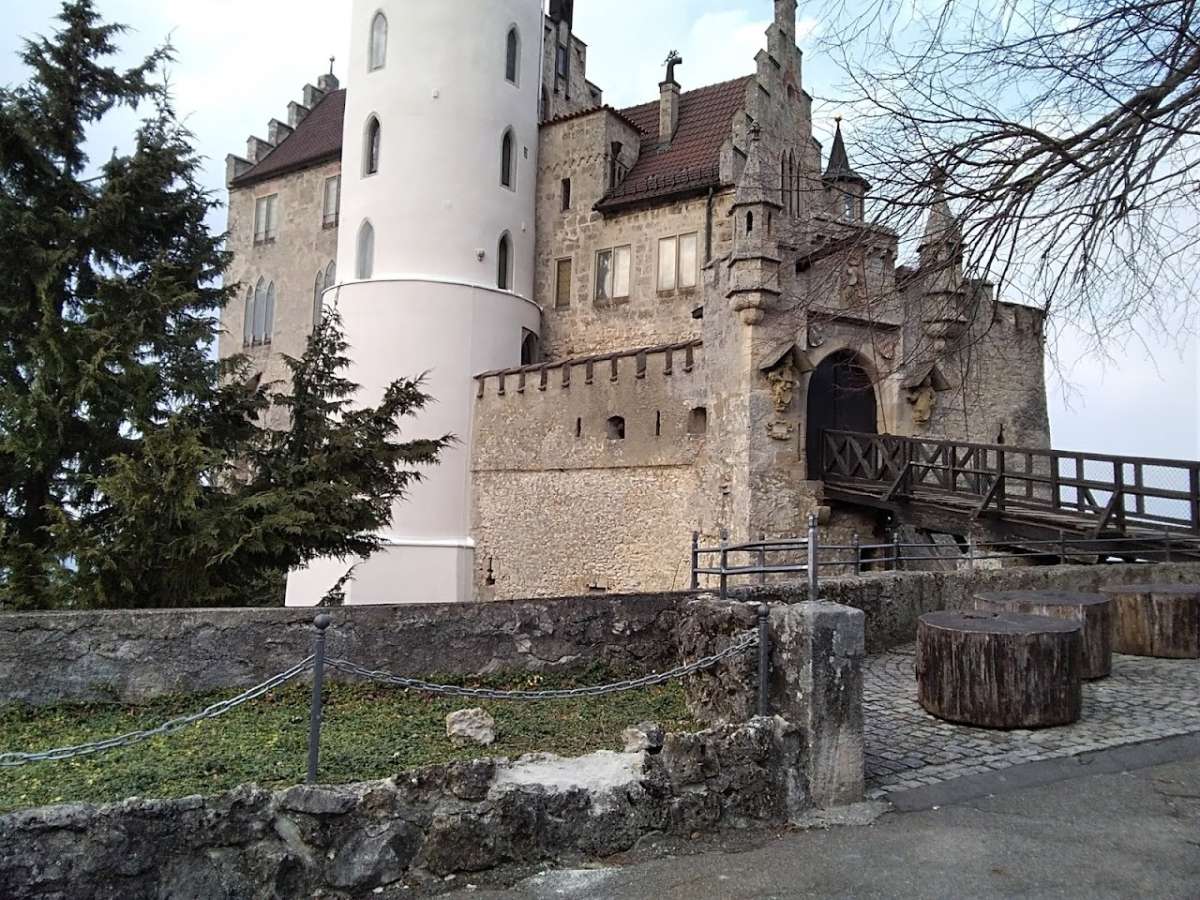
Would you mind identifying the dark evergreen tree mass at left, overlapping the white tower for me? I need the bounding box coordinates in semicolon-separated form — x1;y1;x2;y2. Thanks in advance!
0;0;446;608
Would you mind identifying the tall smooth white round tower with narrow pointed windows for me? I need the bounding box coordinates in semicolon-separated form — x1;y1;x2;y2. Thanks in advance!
288;0;542;605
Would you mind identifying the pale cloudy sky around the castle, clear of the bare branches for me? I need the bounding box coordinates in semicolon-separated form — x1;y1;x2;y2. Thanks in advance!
0;0;1200;458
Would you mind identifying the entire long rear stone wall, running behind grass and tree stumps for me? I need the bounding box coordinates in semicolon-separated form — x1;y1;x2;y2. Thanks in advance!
0;563;1200;706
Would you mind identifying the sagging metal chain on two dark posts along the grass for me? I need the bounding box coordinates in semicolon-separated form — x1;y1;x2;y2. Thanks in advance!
0;619;768;784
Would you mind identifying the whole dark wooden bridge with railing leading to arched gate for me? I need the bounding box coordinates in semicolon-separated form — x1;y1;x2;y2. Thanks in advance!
821;431;1200;558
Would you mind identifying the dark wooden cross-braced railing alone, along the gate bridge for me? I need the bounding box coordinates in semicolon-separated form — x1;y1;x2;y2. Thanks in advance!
822;431;1200;534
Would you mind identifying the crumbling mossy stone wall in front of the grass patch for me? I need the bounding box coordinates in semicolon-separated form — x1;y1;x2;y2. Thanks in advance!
0;718;809;900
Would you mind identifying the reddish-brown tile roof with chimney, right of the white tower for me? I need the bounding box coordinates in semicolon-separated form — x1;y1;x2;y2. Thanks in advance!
598;76;751;210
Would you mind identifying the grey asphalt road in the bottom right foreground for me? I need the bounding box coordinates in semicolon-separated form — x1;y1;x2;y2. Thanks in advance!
454;736;1200;900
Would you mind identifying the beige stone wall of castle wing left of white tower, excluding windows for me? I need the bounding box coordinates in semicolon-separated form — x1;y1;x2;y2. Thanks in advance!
218;161;341;425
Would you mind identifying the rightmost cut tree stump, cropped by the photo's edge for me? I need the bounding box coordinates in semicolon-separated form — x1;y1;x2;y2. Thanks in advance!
1100;584;1200;659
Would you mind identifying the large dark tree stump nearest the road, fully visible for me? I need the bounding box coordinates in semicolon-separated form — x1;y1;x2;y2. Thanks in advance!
917;611;1084;728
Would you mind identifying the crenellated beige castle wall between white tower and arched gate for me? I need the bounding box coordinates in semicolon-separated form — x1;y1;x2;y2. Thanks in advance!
472;347;707;598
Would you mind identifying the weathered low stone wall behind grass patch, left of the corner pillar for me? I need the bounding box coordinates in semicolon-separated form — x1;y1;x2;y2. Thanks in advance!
0;594;678;706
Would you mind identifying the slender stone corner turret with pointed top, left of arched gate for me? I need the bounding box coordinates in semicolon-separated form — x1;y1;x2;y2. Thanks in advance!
726;122;782;325
